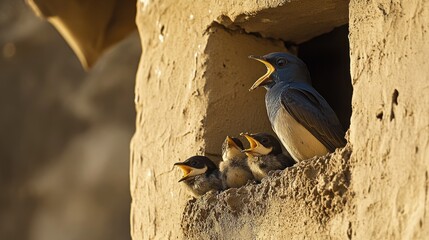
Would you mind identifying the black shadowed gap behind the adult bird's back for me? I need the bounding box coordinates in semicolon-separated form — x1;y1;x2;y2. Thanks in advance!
298;25;353;130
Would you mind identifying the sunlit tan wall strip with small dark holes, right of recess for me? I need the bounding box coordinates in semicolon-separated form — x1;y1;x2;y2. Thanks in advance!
350;1;429;239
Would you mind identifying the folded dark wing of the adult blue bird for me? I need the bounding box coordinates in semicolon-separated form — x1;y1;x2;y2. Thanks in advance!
281;87;346;152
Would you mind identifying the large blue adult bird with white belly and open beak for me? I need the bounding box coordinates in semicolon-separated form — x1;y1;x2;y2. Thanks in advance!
250;53;346;161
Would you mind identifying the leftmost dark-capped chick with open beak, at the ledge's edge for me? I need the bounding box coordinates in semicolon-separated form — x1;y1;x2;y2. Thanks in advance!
174;156;224;197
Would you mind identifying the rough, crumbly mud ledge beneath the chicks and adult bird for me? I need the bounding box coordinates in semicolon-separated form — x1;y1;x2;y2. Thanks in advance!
182;147;351;239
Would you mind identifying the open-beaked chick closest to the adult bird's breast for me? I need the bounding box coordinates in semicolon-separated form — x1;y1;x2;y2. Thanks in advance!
242;133;295;181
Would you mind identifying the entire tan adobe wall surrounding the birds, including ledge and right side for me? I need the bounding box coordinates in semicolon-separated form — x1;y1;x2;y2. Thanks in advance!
130;0;429;239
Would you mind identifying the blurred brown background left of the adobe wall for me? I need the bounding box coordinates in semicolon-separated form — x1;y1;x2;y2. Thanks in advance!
0;0;141;240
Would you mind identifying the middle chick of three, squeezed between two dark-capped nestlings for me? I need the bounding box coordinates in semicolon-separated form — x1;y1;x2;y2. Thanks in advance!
219;136;253;188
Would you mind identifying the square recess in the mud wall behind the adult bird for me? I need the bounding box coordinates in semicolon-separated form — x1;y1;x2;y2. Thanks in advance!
204;13;353;161
